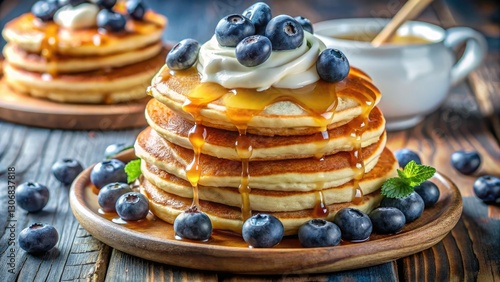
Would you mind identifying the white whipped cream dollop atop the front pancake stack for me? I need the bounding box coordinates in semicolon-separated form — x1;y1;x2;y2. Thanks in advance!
197;32;326;91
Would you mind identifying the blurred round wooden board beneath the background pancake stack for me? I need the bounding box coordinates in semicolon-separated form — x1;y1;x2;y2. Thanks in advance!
0;80;150;130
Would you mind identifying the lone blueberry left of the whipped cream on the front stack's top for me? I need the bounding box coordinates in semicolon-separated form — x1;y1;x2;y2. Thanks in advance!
166;38;200;70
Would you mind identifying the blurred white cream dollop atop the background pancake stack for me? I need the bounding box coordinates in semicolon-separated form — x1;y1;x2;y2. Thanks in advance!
54;3;100;29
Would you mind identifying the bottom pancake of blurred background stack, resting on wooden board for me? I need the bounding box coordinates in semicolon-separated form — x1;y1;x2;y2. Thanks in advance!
4;46;168;104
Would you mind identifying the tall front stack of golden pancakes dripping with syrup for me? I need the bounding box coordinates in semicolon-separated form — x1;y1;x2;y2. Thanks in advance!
135;66;397;235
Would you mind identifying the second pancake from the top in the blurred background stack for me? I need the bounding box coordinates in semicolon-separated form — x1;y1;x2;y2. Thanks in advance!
3;42;163;73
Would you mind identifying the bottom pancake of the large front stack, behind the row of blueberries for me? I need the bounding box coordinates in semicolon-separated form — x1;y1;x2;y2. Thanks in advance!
140;179;382;235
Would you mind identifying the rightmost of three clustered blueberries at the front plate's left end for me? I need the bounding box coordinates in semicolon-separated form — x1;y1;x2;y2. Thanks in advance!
115;192;149;221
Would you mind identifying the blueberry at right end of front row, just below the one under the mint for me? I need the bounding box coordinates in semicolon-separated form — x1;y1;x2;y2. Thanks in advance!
370;207;406;234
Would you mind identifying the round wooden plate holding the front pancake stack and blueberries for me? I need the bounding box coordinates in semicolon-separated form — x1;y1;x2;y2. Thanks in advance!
70;150;462;274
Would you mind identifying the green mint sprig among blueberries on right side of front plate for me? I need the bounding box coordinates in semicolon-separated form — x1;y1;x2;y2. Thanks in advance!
382;161;436;198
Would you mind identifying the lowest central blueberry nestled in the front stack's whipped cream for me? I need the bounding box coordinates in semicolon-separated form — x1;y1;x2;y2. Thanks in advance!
235;35;272;67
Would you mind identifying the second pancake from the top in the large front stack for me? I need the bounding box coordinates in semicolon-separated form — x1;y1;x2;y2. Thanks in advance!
146;99;385;160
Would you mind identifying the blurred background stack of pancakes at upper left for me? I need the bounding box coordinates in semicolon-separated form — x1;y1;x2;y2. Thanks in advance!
2;3;166;104
